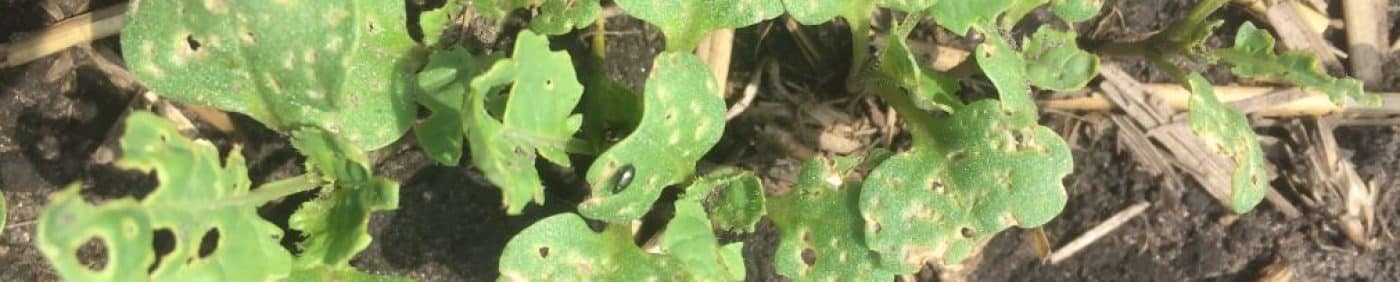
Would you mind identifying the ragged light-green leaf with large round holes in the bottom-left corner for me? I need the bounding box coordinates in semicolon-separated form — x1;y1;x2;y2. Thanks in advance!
36;111;295;281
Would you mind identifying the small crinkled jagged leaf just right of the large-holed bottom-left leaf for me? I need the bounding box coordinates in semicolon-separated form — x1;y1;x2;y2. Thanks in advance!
287;128;399;281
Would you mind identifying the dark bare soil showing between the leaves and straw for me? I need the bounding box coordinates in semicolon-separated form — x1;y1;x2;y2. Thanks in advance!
0;0;1400;281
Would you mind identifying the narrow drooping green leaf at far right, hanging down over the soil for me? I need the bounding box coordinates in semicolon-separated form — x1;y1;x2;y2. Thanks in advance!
1187;73;1268;213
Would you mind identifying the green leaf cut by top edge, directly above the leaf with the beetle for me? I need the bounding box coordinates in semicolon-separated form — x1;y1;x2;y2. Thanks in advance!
616;0;783;52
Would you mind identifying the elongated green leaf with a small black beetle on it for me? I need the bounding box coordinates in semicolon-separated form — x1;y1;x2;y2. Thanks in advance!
579;52;727;223
